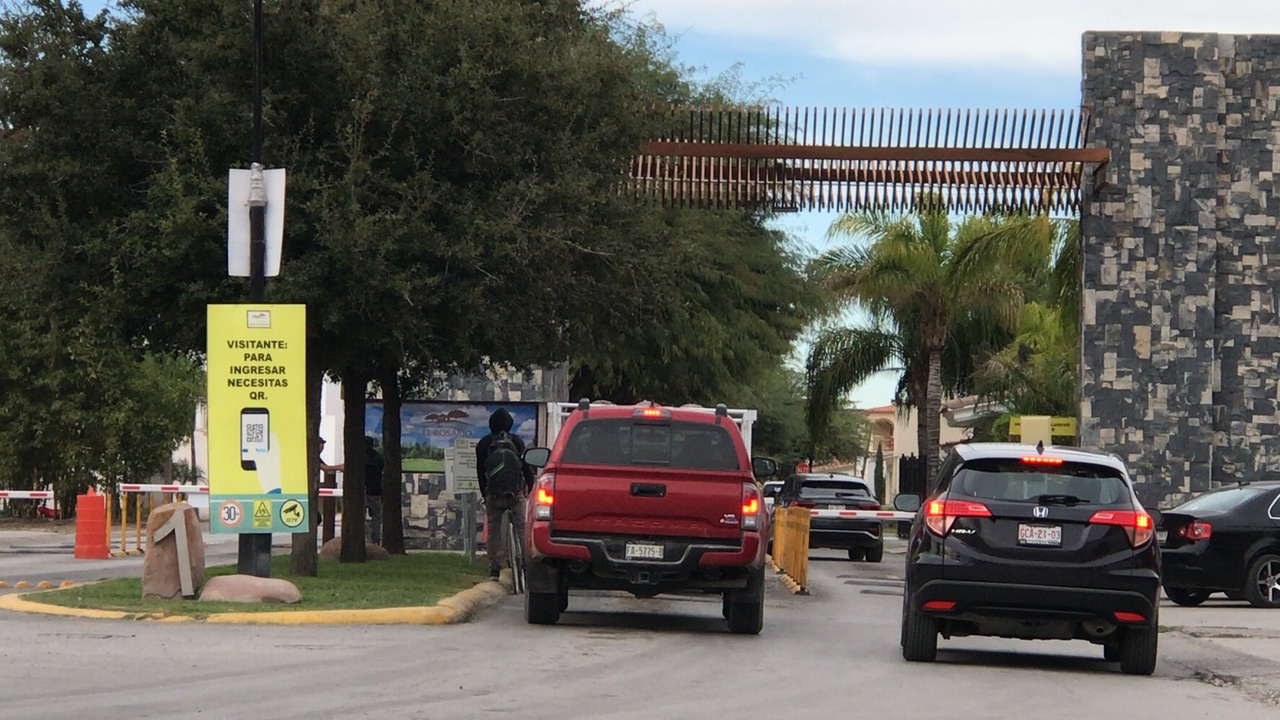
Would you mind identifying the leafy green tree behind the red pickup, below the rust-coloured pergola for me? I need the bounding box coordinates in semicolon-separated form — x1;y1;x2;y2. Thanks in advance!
570;210;819;405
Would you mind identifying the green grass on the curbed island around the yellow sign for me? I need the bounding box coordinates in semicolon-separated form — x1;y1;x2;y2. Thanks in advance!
24;552;489;616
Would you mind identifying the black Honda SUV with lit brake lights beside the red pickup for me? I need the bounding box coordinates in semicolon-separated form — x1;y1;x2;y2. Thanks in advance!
897;443;1160;675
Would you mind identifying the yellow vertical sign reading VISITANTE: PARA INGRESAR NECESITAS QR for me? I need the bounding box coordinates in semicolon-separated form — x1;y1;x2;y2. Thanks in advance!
207;304;307;533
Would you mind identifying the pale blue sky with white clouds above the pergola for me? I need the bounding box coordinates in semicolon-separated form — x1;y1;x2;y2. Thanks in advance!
631;0;1280;407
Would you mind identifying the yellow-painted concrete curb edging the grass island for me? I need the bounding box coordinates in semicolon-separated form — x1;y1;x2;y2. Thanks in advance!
0;578;511;625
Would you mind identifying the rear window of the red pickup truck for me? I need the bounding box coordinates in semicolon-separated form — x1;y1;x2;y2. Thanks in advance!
561;418;739;470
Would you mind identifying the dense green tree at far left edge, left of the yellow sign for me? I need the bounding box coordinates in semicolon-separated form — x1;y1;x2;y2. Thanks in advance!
0;0;202;507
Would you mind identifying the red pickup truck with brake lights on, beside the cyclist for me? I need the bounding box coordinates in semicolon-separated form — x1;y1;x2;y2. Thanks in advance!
525;400;776;634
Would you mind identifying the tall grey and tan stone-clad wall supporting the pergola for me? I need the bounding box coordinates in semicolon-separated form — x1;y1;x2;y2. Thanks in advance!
1080;32;1280;506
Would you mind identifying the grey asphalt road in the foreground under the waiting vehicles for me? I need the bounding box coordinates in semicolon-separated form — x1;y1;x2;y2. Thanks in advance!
0;540;1280;720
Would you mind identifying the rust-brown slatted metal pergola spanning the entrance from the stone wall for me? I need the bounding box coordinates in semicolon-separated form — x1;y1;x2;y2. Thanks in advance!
628;106;1110;214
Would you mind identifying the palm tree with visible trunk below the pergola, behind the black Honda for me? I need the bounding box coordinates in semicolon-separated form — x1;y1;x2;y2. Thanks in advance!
808;202;1048;483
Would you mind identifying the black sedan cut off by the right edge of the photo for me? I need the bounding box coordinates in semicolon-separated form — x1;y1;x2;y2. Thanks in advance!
1157;482;1280;607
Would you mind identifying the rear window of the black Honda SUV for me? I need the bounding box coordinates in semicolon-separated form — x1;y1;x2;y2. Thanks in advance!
951;459;1129;505
